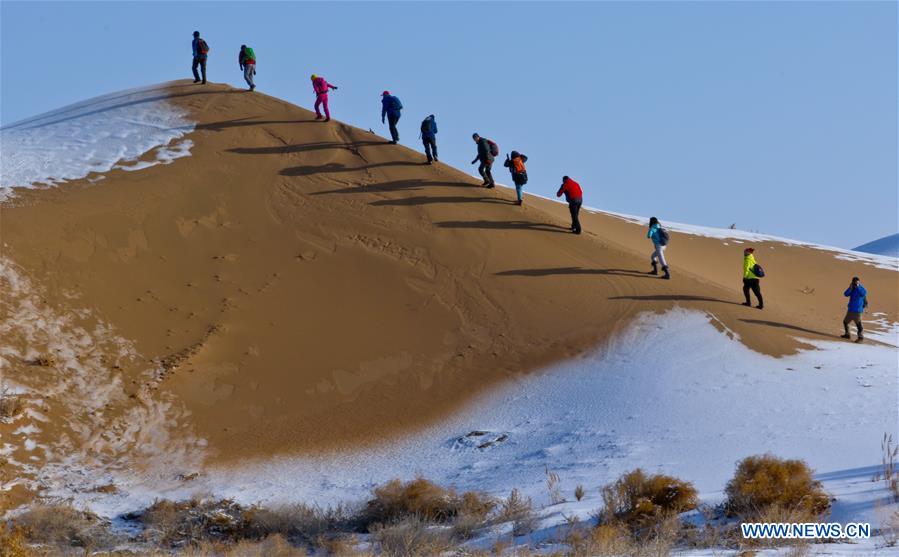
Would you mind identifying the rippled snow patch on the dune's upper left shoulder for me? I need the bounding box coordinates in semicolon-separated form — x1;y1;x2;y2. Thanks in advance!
0;83;194;201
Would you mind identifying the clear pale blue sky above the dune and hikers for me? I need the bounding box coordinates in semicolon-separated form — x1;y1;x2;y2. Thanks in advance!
0;0;899;247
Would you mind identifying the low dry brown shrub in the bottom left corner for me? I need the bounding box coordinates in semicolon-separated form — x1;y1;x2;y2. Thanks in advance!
16;503;118;551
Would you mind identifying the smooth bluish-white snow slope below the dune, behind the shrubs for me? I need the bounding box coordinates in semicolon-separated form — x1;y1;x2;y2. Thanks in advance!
58;310;899;543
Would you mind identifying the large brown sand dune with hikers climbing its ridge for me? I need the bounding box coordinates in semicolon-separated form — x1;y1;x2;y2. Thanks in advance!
0;82;899;504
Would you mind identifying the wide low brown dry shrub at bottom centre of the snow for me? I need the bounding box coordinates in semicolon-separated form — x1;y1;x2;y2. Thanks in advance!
364;478;496;527
